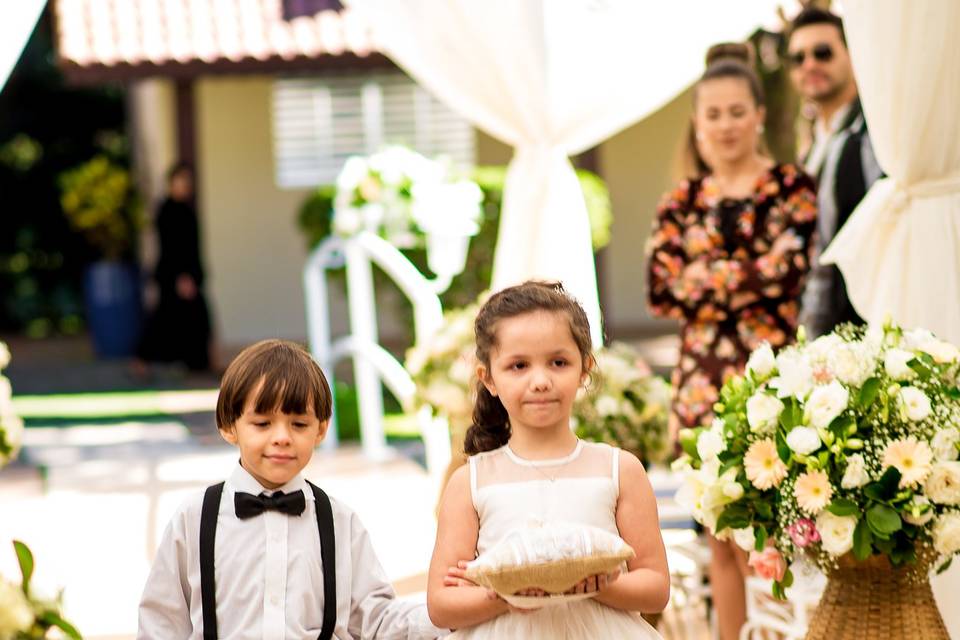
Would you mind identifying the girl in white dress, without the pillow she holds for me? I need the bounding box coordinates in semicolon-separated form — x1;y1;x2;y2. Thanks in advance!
427;282;670;639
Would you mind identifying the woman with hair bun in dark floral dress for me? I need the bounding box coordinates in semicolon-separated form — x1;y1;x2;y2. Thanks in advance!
648;45;817;640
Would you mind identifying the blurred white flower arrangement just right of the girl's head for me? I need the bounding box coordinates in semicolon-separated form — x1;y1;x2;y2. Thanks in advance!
573;342;670;463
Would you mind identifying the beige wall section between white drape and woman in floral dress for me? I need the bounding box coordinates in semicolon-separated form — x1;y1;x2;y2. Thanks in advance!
600;87;691;337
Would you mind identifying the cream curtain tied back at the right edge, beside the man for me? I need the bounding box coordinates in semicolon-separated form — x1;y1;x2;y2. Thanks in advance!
823;0;960;348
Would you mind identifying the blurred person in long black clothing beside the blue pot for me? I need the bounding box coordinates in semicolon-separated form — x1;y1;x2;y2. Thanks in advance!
134;163;210;373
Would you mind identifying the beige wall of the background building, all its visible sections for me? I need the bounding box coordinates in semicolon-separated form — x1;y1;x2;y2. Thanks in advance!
136;76;690;352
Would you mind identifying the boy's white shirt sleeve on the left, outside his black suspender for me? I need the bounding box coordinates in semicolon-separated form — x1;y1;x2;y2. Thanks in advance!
137;510;193;640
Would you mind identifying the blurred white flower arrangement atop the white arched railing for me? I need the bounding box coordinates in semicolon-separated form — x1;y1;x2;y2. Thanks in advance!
333;146;483;248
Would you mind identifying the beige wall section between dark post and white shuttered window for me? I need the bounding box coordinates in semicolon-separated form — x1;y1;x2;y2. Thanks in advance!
195;76;316;350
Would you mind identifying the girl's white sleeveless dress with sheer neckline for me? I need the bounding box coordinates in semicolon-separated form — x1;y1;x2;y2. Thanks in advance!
450;440;660;640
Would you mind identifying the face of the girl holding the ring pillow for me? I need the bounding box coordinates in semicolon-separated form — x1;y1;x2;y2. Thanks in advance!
477;311;587;431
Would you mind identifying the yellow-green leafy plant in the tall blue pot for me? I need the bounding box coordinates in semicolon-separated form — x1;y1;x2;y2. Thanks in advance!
60;155;142;260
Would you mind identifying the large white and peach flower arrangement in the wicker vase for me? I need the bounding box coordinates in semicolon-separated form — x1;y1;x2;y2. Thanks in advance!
675;324;960;598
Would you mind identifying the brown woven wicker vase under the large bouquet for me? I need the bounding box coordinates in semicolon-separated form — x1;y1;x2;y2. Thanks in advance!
807;554;950;640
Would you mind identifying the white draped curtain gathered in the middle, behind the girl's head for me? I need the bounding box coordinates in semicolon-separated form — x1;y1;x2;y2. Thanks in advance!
348;0;779;343
